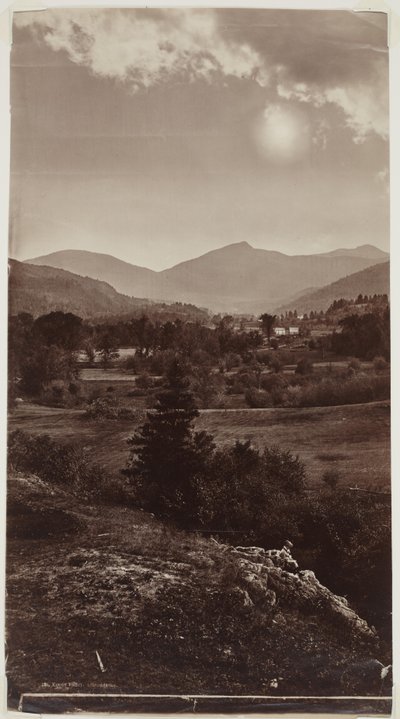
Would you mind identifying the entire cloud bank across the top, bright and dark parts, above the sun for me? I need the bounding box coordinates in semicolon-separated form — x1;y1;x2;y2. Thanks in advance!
14;9;388;148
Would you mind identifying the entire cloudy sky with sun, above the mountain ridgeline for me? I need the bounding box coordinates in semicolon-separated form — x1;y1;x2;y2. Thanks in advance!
10;9;389;270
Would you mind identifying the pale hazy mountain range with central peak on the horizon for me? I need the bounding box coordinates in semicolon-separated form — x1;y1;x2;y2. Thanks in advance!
25;242;388;313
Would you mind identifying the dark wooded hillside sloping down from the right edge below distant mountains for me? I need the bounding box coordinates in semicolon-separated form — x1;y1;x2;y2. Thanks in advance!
277;262;390;312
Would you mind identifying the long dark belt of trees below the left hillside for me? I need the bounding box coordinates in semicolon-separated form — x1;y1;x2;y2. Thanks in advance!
9;312;262;395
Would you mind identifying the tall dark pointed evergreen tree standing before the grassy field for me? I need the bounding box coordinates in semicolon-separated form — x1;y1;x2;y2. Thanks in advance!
124;359;214;524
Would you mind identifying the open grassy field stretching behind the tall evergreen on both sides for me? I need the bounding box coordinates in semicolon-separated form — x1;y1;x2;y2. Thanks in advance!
9;401;390;490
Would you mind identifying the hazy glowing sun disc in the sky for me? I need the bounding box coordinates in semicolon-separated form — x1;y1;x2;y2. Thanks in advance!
255;105;310;164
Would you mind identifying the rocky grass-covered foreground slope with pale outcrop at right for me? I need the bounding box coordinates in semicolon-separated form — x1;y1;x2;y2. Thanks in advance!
7;475;387;713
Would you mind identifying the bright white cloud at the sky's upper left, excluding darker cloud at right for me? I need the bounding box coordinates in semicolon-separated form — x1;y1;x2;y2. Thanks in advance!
15;9;268;90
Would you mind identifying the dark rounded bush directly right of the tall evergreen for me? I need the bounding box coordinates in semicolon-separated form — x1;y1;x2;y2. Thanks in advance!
192;442;306;547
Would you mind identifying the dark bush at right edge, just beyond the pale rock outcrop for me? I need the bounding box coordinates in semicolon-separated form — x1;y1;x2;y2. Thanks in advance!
298;488;391;636
